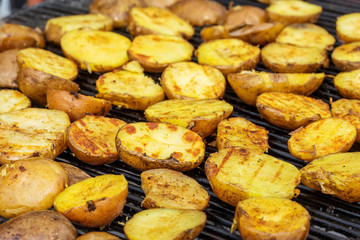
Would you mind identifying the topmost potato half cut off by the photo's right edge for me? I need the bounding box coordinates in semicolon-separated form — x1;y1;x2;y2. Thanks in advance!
336;12;360;43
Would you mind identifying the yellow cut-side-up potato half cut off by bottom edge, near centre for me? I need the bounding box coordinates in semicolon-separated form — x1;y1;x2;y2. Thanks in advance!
124;208;206;240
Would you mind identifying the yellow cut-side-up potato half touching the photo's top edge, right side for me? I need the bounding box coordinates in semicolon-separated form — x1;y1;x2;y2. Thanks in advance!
266;0;322;25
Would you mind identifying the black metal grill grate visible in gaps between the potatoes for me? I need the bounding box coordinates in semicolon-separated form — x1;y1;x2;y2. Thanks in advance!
2;0;360;240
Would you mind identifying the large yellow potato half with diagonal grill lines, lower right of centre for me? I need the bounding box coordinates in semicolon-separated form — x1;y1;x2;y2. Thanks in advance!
205;148;300;206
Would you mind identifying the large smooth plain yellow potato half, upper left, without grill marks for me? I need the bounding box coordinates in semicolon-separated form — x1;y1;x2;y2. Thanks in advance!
60;30;131;73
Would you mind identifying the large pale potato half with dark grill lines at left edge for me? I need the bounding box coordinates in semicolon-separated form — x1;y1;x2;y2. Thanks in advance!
0;108;70;164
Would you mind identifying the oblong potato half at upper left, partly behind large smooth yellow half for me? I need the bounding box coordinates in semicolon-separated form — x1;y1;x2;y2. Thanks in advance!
44;14;113;45
